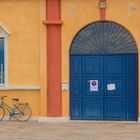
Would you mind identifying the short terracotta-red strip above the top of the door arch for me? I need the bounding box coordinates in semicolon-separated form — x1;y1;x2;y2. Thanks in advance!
99;0;107;21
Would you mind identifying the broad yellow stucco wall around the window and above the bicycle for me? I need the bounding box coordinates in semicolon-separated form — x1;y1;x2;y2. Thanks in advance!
0;0;44;116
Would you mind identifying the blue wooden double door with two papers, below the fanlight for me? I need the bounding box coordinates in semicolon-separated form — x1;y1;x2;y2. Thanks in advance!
70;55;137;120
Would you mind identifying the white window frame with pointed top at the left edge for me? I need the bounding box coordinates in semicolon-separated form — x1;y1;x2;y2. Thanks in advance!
0;23;10;87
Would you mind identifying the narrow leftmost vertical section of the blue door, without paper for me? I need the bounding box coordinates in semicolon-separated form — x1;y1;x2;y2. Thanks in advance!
70;56;82;119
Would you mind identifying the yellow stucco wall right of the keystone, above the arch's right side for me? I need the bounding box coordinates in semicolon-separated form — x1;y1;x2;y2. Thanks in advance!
107;0;140;117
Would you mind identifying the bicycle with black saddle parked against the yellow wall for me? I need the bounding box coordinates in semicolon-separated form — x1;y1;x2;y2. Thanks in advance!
0;96;32;122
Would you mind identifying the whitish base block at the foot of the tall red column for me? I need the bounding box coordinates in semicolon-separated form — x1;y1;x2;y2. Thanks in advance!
38;117;70;122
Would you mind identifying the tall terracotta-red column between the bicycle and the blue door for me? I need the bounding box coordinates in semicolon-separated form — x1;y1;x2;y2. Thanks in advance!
43;0;62;117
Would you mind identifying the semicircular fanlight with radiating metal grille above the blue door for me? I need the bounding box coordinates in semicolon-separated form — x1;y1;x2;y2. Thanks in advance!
70;21;138;54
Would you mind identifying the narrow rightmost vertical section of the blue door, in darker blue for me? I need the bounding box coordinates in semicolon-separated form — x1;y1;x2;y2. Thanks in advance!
125;55;138;120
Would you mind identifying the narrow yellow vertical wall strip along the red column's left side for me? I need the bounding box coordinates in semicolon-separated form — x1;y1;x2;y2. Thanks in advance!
40;0;47;116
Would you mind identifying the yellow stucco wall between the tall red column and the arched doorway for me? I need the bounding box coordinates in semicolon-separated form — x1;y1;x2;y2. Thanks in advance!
62;0;99;116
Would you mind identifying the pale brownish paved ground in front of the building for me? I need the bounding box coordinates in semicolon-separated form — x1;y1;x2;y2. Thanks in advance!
0;121;140;140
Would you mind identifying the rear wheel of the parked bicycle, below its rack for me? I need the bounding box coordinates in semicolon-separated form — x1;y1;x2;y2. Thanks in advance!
14;103;32;122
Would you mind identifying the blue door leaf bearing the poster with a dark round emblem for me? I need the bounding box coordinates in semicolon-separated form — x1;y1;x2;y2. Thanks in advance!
82;56;104;120
